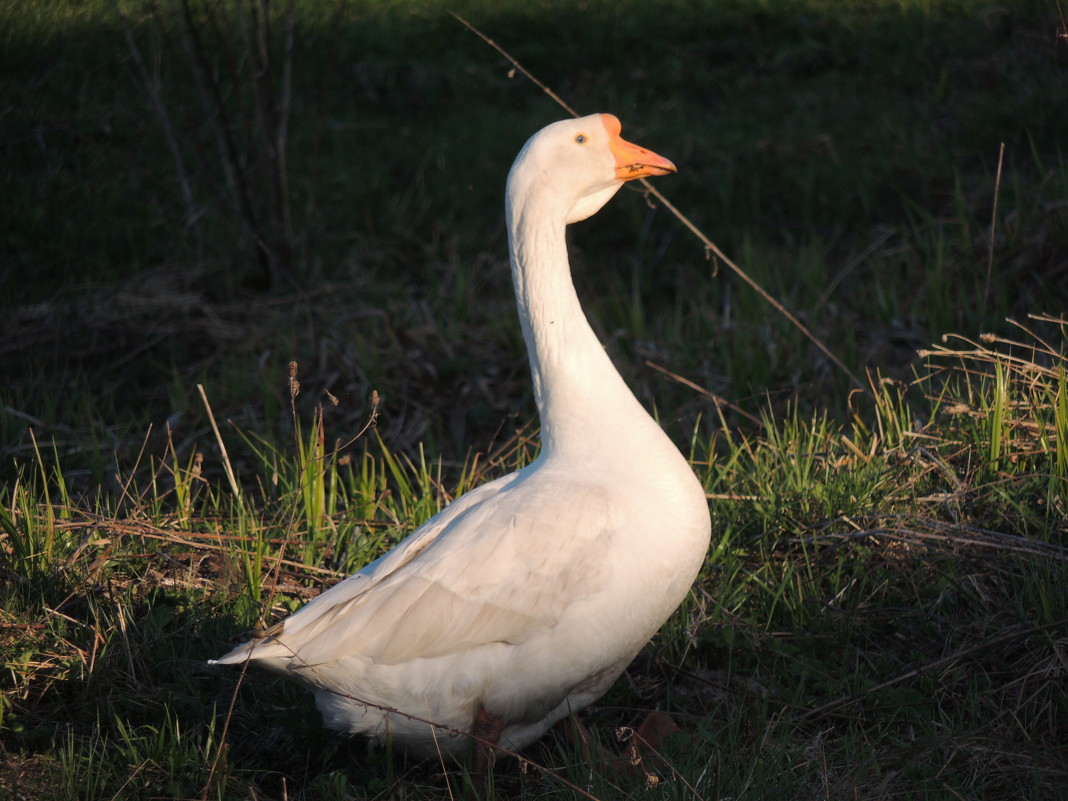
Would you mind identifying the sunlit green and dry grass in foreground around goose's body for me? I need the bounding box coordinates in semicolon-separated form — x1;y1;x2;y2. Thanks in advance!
0;326;1068;799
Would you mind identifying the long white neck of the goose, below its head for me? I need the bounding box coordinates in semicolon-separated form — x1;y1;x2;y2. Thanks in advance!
506;187;678;460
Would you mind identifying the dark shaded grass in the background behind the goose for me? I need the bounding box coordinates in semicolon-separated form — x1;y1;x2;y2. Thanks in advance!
0;0;1068;474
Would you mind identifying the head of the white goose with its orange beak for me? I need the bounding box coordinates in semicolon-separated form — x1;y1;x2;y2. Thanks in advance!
507;114;677;224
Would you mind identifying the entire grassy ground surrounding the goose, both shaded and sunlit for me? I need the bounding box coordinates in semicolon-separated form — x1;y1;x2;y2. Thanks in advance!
0;0;1068;799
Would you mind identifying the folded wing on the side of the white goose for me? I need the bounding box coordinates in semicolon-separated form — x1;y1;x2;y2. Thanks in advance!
230;473;617;669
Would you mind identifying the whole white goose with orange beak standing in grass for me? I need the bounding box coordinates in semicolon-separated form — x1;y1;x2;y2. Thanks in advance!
217;114;711;755
